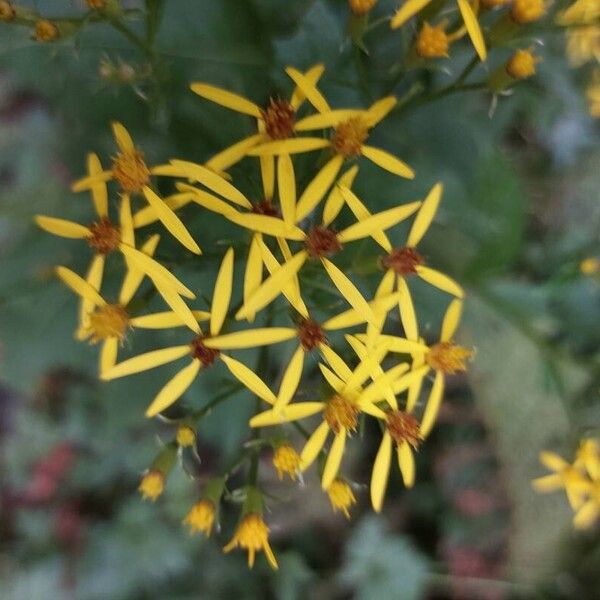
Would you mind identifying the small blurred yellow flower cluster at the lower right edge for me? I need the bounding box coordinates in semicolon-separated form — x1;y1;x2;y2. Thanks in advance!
533;438;600;529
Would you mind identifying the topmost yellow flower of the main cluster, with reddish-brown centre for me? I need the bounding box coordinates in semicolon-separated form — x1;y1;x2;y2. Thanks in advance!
191;65;329;173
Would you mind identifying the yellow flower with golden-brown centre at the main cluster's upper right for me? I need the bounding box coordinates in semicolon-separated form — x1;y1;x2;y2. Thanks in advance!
248;95;415;179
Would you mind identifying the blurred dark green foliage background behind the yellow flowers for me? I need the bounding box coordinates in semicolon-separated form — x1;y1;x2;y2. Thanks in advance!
0;0;600;600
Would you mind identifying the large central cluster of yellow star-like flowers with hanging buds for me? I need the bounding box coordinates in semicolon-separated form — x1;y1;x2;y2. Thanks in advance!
36;65;472;567
